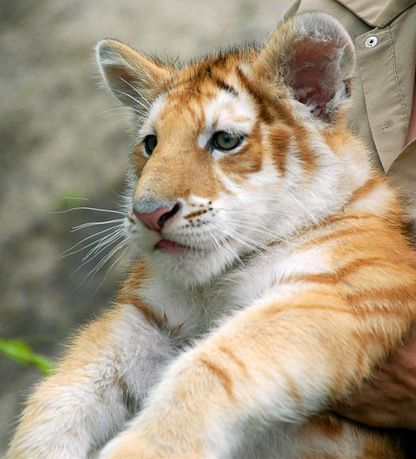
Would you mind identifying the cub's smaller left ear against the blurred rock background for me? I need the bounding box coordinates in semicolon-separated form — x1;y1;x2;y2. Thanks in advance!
96;39;174;113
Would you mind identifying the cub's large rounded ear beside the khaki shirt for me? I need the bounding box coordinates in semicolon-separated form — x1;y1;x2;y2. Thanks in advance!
257;12;355;121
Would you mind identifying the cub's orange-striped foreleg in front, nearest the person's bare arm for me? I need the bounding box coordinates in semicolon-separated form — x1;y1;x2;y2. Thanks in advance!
100;287;410;459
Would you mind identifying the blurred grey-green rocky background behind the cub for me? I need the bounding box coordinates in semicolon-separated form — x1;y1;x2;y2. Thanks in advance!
0;0;291;452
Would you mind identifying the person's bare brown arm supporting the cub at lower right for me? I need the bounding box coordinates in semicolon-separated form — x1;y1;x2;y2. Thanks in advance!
335;325;416;431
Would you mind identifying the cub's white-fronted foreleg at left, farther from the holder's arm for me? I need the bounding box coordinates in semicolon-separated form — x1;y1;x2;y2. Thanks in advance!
8;304;174;459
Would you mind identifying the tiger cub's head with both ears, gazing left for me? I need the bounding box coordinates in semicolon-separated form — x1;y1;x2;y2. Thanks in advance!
97;13;357;284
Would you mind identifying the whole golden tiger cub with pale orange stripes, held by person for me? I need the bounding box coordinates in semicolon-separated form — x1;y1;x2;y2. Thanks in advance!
9;13;416;459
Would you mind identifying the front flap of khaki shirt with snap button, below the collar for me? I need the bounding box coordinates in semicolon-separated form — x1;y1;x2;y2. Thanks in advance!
354;7;416;172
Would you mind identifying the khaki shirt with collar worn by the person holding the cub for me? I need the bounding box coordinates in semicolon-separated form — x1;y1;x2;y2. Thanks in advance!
285;0;416;220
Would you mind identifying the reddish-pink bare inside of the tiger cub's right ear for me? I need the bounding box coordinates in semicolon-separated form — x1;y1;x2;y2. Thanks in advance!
289;37;339;117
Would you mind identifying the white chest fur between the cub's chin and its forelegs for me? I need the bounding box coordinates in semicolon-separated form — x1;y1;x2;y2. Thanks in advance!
138;244;328;339
